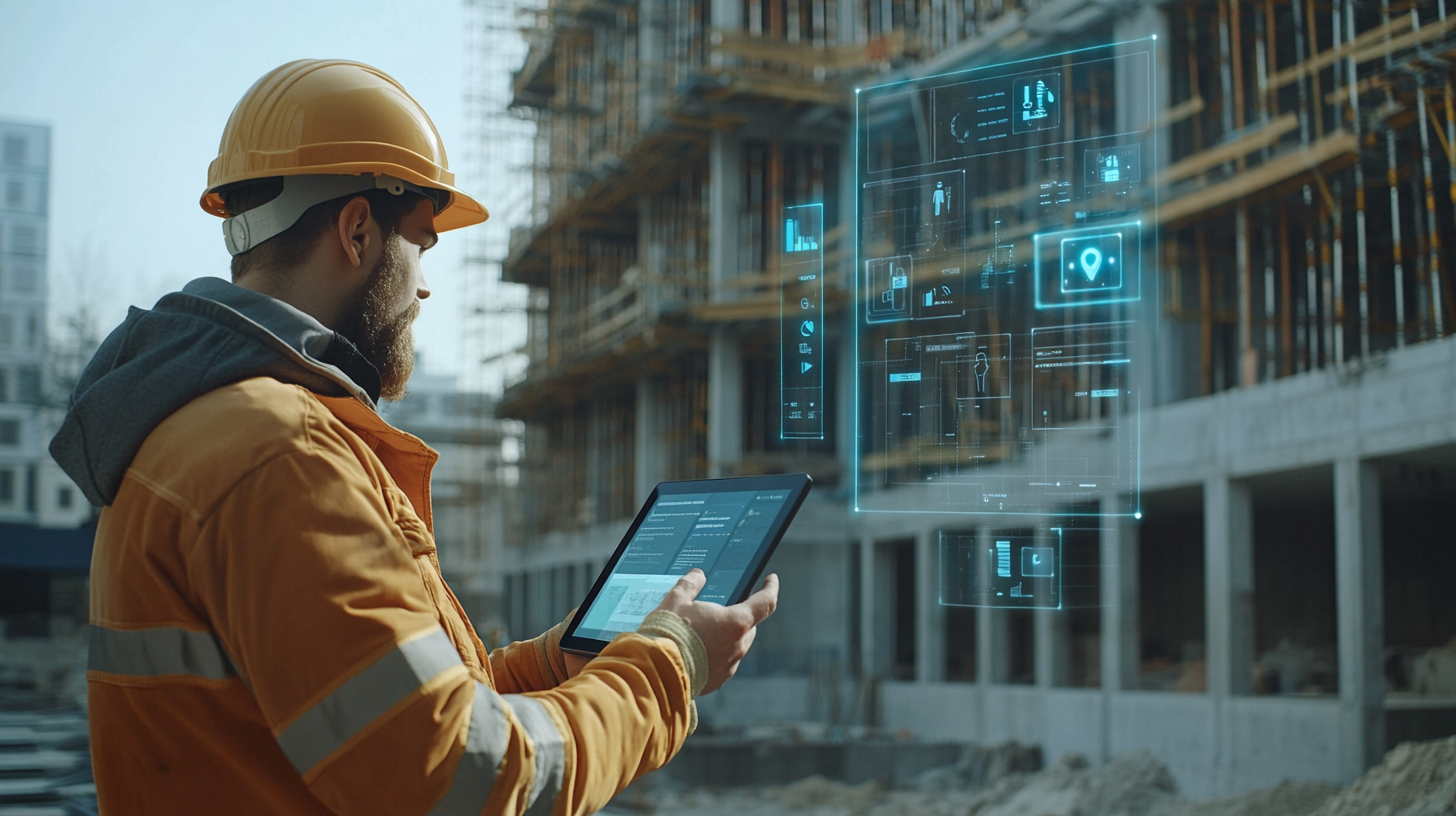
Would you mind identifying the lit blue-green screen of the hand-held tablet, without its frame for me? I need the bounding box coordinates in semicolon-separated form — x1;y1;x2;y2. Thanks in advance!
575;488;794;641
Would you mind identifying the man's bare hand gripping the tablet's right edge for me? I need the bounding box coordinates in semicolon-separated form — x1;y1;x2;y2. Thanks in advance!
657;570;779;694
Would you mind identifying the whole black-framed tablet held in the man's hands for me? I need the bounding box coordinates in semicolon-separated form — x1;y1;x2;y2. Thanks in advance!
561;474;814;654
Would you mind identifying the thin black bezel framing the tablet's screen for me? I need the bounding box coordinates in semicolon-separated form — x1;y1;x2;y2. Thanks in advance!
561;474;814;657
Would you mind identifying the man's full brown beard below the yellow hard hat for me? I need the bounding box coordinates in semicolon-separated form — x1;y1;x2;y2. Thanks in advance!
338;233;419;399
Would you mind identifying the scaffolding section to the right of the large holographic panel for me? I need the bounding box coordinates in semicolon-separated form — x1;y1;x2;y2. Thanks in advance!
1159;0;1456;396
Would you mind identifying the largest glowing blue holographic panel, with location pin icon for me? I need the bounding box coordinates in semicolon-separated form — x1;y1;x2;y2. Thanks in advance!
855;39;1158;515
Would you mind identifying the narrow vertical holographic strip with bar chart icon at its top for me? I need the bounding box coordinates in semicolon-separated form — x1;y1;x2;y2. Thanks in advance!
779;204;824;439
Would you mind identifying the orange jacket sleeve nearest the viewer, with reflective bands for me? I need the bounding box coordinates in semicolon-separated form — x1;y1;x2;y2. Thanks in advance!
188;434;692;816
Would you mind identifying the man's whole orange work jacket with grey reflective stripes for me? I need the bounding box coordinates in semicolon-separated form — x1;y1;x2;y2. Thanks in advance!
87;377;690;815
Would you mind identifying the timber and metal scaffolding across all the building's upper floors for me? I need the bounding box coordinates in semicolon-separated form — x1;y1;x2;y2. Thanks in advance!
480;0;1456;542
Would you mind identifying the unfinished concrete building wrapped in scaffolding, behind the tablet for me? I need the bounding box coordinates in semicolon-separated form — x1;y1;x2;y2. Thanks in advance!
486;0;1456;796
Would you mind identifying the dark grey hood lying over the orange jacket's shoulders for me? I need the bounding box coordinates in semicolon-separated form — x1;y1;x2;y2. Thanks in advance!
51;278;380;506
